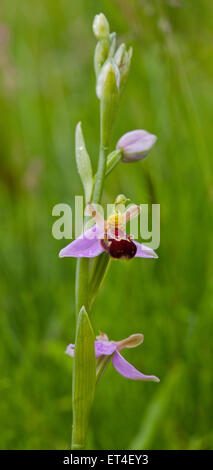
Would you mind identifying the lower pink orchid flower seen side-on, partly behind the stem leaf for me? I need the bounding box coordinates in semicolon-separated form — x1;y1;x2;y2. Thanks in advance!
65;333;160;382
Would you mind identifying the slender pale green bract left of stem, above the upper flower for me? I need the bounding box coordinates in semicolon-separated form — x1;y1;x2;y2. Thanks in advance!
75;122;93;203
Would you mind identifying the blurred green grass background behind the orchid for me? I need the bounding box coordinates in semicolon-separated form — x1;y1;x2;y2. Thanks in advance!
0;0;213;449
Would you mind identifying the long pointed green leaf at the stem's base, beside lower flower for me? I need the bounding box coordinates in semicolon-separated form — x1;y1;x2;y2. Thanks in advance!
72;307;96;449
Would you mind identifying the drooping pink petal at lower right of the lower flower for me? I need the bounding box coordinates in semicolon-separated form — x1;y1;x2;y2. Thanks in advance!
112;351;160;382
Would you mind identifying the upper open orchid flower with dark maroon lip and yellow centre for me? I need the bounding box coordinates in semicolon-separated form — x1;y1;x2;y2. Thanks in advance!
59;203;158;259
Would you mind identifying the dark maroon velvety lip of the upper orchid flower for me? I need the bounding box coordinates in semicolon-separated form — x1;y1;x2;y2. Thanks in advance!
100;237;137;259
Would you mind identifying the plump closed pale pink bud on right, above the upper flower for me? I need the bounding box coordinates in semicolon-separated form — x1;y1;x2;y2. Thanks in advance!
116;129;157;163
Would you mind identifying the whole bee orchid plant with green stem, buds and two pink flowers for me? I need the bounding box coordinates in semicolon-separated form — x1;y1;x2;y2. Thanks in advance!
60;13;159;449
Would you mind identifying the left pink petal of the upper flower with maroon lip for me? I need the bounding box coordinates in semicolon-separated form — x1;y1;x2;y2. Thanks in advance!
59;225;104;258
